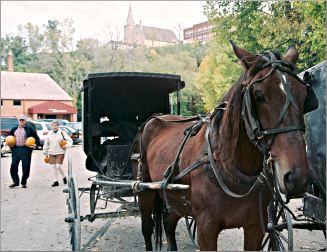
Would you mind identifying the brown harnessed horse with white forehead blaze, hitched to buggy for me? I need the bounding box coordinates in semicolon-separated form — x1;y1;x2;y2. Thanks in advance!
132;41;317;251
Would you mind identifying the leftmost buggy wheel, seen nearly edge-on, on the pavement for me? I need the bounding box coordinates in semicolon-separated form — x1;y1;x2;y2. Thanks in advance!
66;157;81;251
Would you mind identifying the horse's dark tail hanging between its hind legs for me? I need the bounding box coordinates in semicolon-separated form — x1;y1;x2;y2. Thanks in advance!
152;193;164;250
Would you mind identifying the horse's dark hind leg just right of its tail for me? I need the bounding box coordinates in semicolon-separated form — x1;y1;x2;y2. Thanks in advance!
163;211;181;251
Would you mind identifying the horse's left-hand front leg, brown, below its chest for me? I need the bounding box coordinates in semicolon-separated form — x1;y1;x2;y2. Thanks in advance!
196;214;220;251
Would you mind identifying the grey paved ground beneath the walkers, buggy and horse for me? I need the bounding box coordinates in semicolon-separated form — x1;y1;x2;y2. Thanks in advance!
1;145;325;251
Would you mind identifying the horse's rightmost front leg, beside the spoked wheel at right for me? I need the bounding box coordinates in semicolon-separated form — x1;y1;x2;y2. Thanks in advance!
243;223;265;251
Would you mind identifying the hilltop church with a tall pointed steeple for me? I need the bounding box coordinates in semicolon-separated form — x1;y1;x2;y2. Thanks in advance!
124;5;177;47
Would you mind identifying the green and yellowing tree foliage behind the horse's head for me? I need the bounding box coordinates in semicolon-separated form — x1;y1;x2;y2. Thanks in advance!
196;1;326;111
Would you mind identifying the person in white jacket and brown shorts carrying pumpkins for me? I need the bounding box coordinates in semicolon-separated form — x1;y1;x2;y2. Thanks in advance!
43;120;73;186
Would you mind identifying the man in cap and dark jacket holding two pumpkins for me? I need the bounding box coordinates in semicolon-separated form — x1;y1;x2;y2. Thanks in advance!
9;115;40;188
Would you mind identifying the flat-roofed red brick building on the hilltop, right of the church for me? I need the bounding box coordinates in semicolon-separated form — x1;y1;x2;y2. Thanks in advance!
183;21;213;43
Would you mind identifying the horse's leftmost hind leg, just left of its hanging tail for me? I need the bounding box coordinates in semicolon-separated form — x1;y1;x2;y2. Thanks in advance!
138;190;156;251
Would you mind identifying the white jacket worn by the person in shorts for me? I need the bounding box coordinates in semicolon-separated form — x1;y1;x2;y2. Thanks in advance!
43;129;73;156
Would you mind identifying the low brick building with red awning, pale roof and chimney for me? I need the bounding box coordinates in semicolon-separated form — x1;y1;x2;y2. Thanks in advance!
1;54;77;121
